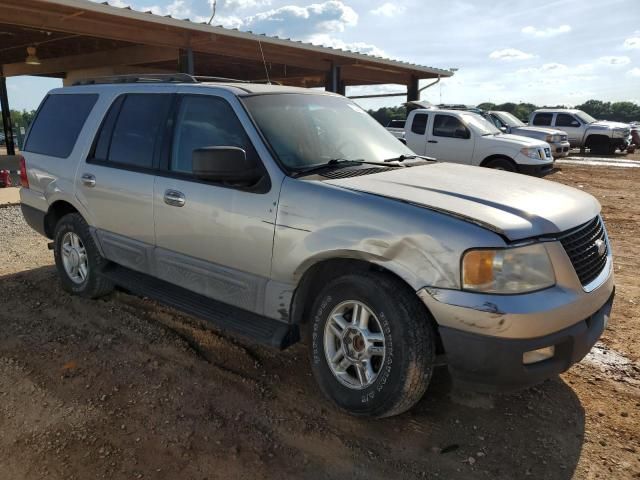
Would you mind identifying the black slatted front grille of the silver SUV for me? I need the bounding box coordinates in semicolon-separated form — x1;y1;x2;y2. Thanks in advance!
559;217;609;286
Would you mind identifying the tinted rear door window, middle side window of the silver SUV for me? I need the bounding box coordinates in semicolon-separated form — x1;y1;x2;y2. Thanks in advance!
107;94;171;168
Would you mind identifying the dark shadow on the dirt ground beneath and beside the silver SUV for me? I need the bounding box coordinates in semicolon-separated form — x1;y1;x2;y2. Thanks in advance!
0;266;585;480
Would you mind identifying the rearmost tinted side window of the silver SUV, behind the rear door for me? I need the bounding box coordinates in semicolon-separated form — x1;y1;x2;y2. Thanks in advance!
24;94;98;158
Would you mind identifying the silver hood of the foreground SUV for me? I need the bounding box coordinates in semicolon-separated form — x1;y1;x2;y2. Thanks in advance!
326;163;600;240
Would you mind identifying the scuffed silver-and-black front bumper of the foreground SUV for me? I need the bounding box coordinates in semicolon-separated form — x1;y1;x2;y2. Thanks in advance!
418;241;615;391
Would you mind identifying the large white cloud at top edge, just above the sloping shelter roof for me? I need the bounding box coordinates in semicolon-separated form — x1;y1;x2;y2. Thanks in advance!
243;0;358;38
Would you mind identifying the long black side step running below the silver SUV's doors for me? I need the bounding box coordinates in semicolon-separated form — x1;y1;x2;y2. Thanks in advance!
101;265;300;350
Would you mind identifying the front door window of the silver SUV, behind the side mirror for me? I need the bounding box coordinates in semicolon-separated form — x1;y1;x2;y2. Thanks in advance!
171;96;257;173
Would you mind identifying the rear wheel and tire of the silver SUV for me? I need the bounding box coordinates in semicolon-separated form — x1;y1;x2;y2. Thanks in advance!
53;213;114;298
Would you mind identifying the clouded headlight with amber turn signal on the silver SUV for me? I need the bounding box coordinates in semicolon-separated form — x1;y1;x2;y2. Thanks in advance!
462;243;556;294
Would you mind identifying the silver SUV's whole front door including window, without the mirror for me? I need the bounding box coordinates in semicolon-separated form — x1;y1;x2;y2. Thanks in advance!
154;94;279;312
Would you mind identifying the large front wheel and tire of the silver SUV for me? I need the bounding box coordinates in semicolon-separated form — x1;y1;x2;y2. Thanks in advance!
308;273;436;417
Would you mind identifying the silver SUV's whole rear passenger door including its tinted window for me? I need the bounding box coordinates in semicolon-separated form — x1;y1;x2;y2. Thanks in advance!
76;89;173;272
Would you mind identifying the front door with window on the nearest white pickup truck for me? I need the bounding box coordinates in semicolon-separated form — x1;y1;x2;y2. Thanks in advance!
425;113;473;164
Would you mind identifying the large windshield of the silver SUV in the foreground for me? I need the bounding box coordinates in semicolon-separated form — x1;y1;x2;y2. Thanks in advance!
242;93;413;171
